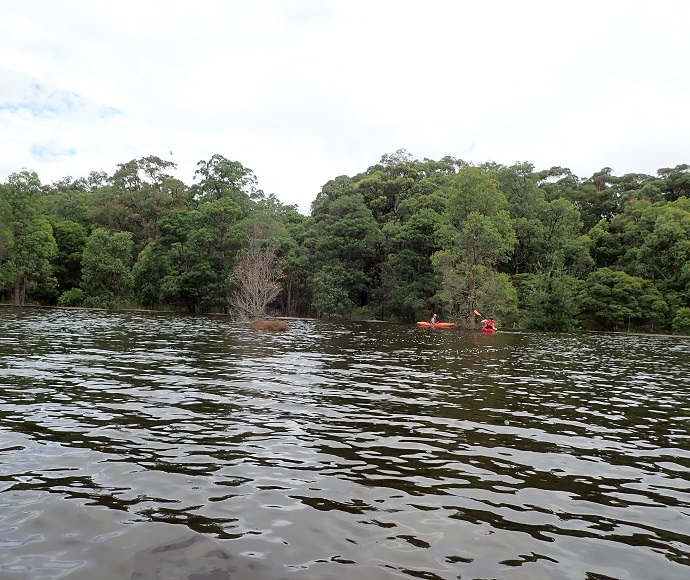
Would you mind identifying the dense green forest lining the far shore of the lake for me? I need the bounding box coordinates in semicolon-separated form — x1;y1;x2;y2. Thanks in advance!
0;150;690;333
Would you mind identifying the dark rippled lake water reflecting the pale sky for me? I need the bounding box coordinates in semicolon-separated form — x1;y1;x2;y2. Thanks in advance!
0;308;690;580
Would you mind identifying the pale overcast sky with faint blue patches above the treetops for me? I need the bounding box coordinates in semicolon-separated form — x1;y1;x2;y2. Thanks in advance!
0;0;690;213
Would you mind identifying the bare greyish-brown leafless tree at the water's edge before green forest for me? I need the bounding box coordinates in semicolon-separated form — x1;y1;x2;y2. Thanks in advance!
228;230;283;320
